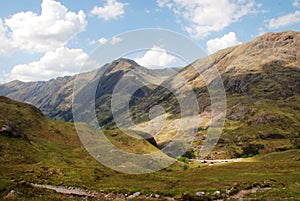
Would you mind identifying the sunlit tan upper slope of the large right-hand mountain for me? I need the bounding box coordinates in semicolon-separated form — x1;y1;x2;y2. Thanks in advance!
196;31;300;77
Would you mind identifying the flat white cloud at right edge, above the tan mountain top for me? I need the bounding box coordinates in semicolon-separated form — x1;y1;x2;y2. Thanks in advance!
268;11;300;29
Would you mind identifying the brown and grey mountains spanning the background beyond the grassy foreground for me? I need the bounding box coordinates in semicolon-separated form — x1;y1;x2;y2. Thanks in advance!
0;31;300;158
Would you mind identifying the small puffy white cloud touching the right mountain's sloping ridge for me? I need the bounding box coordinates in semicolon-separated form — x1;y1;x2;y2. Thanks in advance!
206;32;241;54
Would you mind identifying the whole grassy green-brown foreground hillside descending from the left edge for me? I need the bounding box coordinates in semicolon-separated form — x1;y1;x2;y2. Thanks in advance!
0;97;300;201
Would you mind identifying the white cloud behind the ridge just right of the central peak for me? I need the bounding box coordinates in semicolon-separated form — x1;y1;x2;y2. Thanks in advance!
134;46;177;68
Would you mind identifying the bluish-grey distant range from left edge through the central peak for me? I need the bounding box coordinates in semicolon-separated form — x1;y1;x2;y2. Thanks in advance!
0;59;176;123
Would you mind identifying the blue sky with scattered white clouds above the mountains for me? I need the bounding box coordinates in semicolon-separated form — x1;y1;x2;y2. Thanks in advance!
0;0;300;83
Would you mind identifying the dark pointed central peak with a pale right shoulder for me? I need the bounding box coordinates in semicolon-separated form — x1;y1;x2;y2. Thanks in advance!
76;58;176;128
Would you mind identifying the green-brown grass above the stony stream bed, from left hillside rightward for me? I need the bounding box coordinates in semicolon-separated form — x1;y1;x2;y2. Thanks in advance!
0;98;300;200
